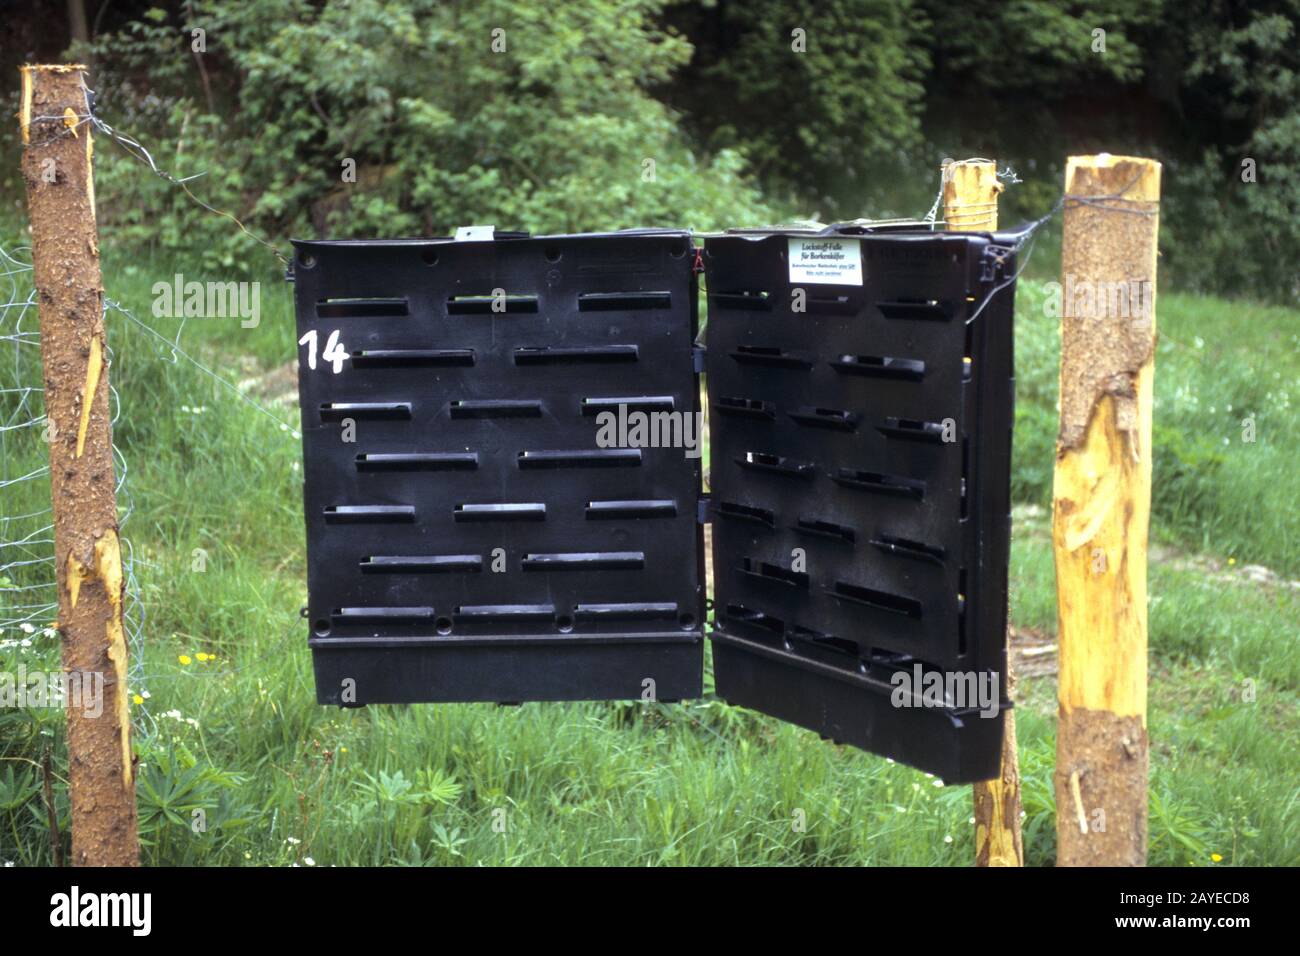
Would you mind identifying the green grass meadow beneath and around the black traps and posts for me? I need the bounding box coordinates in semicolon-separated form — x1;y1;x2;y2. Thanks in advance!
0;244;1300;865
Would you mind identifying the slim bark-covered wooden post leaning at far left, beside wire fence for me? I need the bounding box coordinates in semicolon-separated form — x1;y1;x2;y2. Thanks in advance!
20;65;139;866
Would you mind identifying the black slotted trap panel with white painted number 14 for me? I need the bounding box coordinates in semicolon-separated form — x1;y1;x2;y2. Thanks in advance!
294;232;703;704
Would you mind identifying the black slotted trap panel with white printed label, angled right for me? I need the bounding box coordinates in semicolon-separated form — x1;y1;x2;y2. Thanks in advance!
706;232;1014;782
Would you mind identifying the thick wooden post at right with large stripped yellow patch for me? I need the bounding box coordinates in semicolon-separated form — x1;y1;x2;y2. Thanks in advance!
1052;153;1161;866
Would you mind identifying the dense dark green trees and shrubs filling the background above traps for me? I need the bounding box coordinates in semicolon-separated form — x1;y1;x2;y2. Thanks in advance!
0;0;1300;300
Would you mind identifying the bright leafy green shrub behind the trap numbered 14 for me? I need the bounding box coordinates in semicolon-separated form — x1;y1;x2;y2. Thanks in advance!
86;0;772;274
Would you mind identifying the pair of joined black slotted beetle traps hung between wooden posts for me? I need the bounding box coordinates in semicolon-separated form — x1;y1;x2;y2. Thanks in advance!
293;224;1021;783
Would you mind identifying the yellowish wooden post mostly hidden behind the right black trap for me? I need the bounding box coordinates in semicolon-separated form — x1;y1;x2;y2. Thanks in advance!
944;160;1024;866
